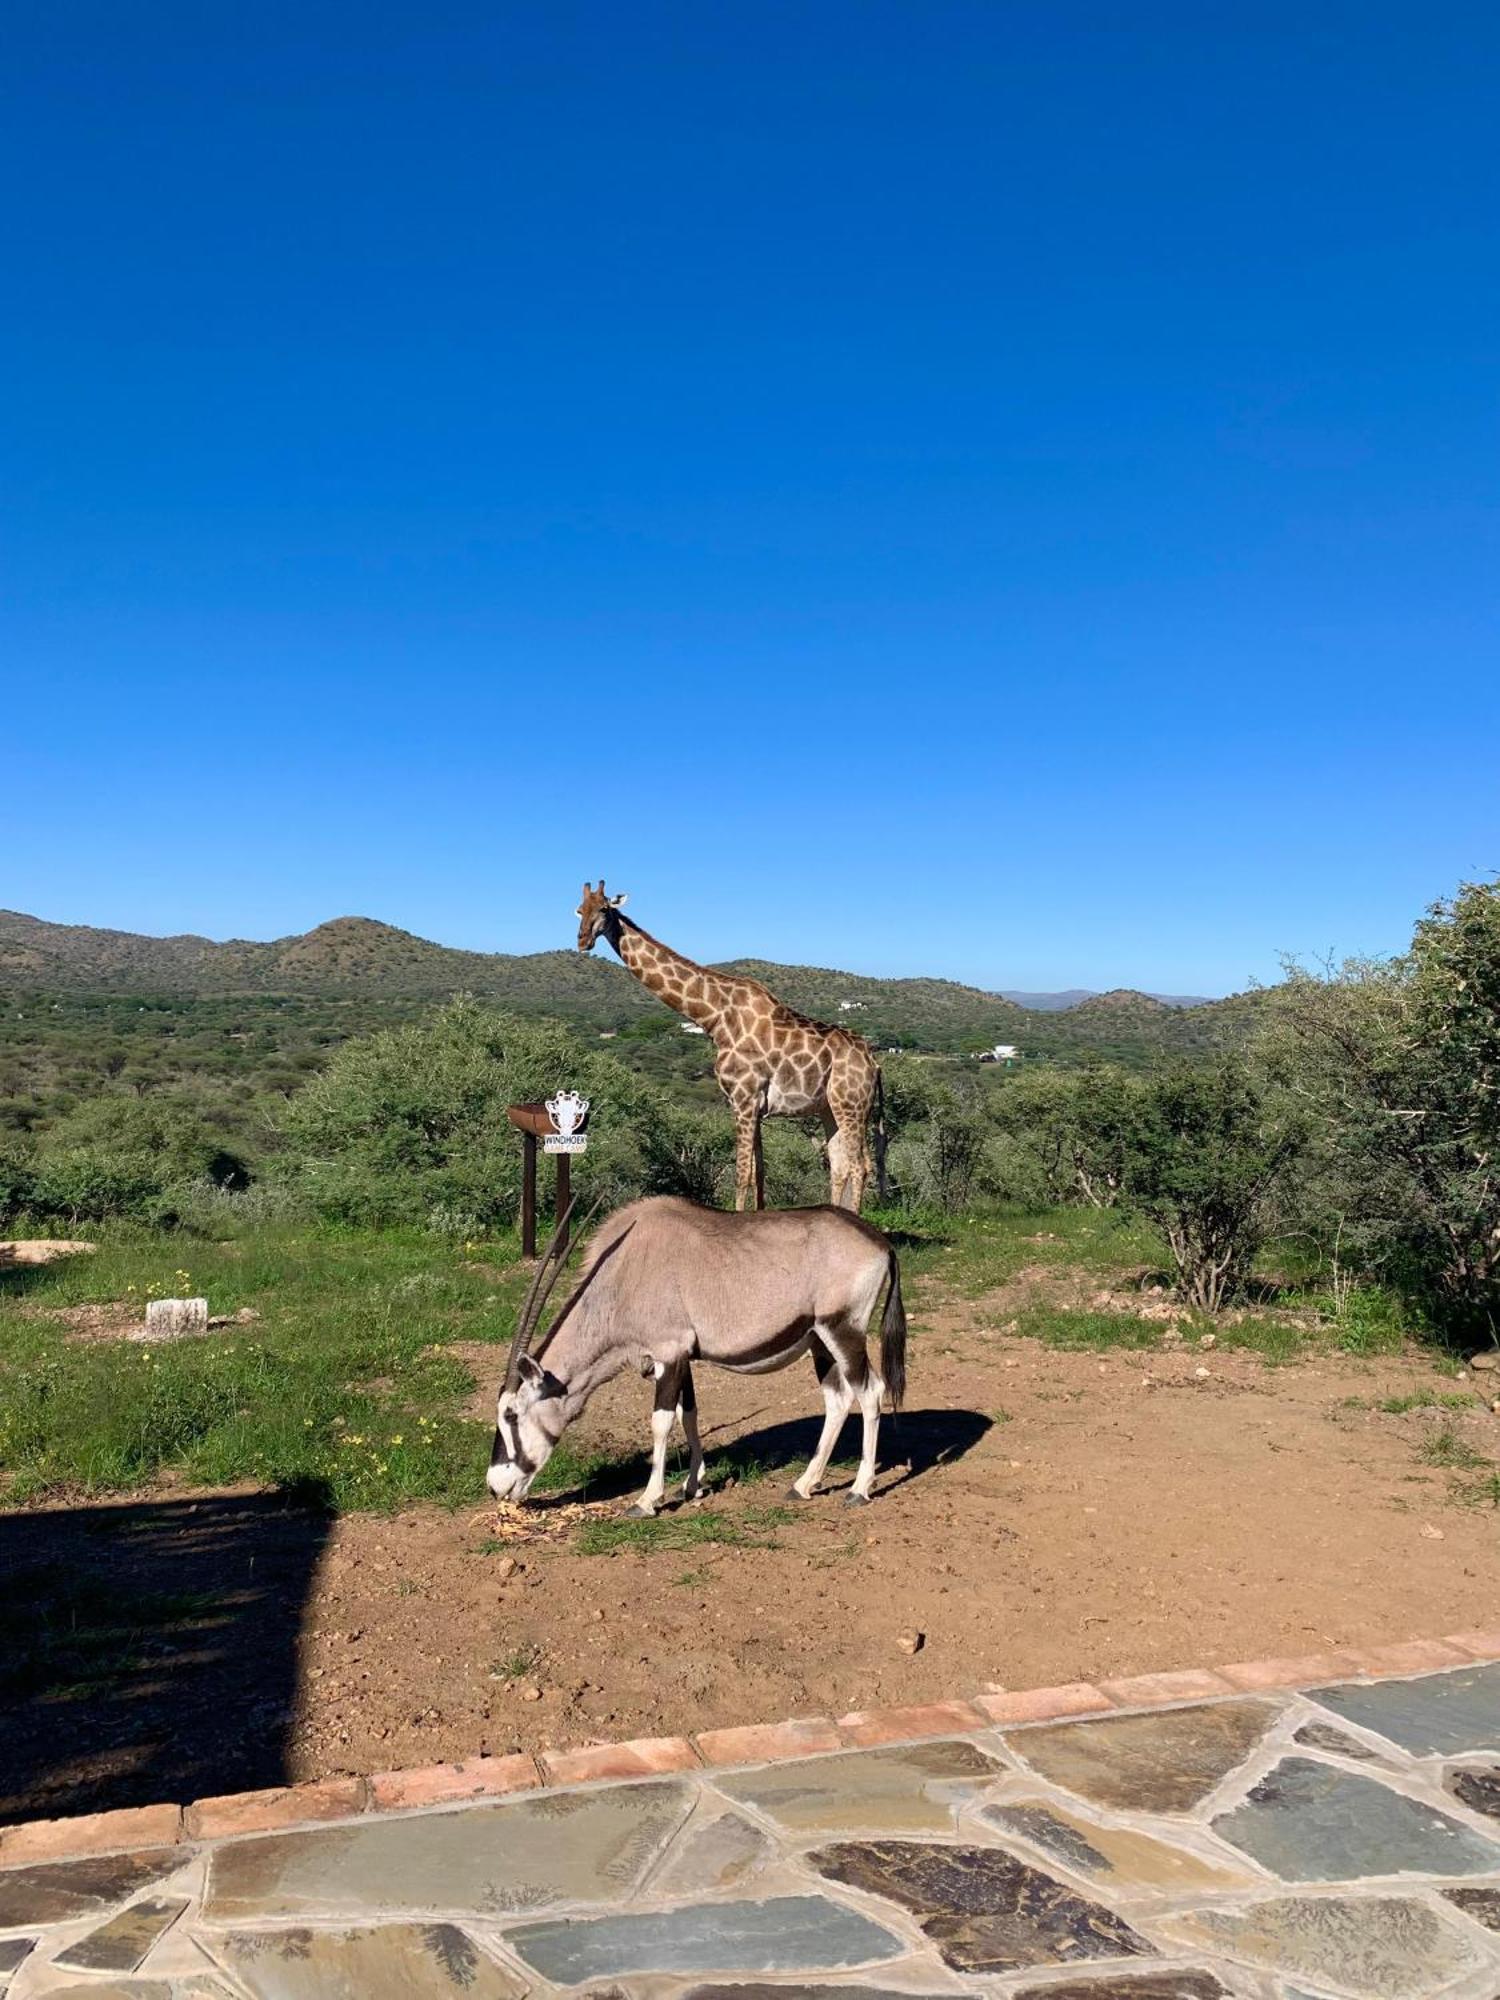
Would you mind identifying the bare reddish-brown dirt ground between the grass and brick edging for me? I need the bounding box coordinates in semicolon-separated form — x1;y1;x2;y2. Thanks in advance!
0;1302;1500;1818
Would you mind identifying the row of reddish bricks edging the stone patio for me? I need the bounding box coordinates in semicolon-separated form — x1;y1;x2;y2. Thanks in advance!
0;1628;1500;1868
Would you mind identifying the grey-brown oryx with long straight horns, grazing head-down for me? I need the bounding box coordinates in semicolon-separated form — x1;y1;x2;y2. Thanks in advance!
488;1194;906;1516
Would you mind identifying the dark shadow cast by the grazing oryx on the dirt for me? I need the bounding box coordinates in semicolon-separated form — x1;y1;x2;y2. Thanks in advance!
548;1410;994;1506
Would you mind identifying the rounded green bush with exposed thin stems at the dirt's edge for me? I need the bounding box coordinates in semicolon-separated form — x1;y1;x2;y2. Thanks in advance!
1124;1056;1304;1312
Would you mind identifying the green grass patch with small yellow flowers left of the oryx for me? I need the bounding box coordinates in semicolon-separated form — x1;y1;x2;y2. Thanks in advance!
0;1230;532;1508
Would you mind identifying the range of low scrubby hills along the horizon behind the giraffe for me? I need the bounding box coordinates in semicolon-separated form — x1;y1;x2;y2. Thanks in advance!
0;910;1254;1062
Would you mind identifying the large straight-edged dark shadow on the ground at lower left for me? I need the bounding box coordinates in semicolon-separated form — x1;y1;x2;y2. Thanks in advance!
0;1492;332;1824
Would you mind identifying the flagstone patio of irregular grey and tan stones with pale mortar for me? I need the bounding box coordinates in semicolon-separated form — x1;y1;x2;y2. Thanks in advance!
0;1658;1500;2000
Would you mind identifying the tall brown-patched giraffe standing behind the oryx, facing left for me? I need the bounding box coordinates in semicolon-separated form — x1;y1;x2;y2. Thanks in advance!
578;880;886;1214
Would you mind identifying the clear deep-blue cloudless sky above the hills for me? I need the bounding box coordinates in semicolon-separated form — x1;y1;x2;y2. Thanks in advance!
0;0;1500;992
